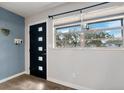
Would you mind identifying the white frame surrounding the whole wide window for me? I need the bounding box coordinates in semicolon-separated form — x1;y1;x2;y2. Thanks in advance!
53;17;124;50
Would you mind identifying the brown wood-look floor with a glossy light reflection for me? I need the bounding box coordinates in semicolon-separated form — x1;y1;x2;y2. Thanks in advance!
0;74;73;90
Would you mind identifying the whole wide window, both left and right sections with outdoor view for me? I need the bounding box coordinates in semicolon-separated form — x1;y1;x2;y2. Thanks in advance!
54;16;123;48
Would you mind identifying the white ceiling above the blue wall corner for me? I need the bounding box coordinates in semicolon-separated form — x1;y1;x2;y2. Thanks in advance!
0;2;64;17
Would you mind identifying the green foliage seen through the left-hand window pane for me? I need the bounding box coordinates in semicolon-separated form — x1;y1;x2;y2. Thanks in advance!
56;31;80;47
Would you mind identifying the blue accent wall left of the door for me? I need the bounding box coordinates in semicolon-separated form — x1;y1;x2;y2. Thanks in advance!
0;8;25;80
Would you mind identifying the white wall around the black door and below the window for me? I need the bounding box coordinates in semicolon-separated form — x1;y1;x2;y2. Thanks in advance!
25;3;124;89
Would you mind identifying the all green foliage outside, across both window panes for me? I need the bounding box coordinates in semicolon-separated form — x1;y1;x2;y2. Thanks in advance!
55;31;123;48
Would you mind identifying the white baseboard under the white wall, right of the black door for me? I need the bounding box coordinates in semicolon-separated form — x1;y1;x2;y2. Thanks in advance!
47;77;92;90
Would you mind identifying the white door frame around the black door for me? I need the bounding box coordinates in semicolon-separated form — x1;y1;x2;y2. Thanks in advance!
25;19;48;77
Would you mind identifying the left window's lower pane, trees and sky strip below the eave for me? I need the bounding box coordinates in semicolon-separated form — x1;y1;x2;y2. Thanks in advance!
55;25;81;48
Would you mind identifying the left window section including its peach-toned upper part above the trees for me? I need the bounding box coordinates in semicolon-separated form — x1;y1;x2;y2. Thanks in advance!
54;15;81;48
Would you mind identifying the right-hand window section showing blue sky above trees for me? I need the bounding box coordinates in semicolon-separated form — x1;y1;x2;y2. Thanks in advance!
84;19;123;47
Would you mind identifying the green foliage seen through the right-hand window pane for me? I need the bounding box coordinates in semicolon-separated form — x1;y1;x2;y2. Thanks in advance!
85;32;122;47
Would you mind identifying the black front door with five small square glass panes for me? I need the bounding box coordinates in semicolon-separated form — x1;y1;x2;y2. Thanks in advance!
30;22;47;79
